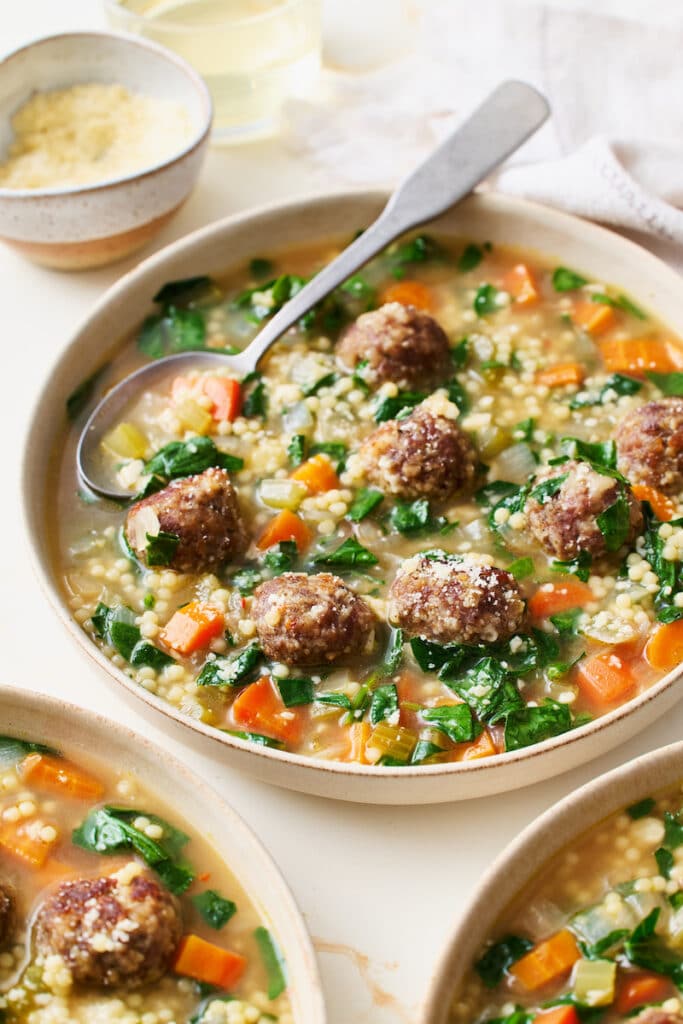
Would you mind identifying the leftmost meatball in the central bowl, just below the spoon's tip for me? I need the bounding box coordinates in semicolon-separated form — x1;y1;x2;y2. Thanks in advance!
125;468;249;572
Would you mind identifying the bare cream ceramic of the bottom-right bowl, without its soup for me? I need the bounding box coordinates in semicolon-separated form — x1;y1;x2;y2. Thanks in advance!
419;742;683;1024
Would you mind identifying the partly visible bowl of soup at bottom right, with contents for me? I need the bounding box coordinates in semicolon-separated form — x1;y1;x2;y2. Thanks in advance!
420;743;683;1024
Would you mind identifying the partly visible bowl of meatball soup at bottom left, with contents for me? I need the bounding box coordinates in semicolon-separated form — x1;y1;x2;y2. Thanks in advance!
0;687;325;1024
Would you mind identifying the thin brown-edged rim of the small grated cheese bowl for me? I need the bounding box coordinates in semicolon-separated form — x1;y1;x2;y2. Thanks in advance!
0;30;213;201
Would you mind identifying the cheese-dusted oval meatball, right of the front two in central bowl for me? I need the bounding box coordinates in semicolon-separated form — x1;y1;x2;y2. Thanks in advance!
388;554;526;643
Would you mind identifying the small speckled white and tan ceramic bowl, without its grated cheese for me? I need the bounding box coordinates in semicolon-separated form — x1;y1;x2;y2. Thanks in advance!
0;32;212;270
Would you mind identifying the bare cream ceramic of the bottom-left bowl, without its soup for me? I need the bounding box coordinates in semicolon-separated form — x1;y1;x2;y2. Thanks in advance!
0;686;326;1024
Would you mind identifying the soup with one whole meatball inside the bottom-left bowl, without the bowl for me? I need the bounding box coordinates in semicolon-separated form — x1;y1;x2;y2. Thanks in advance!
0;736;293;1024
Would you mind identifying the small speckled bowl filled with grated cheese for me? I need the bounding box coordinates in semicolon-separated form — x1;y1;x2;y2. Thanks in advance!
0;32;212;269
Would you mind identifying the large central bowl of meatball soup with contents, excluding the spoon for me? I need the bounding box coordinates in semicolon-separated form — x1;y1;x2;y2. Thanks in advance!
25;194;683;803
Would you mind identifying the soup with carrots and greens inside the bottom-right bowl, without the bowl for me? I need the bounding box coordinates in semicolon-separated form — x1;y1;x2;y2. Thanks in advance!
449;785;683;1024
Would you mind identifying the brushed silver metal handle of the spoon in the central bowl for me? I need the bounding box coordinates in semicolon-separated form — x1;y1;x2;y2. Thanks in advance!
231;81;550;373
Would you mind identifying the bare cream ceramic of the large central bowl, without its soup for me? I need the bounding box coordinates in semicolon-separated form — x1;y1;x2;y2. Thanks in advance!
24;193;683;804
